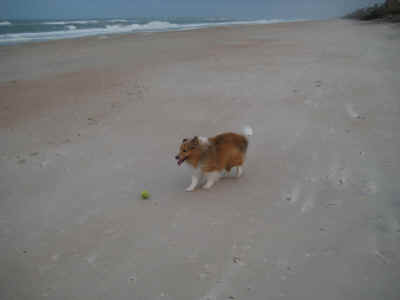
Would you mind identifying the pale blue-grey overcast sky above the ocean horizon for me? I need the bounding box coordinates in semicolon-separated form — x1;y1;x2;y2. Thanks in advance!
0;0;384;19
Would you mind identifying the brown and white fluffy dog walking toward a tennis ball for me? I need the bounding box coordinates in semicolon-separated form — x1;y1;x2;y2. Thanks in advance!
175;126;253;192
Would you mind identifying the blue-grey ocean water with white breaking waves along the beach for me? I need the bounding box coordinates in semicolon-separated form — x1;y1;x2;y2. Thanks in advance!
0;18;295;45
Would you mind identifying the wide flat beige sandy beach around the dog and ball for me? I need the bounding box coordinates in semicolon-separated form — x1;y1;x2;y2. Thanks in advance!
0;20;400;300
